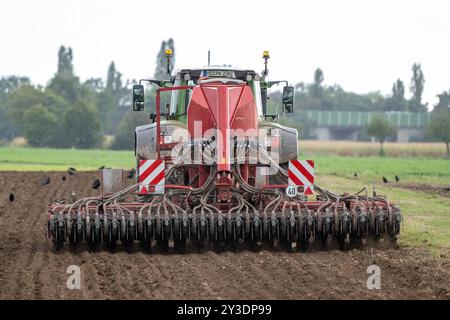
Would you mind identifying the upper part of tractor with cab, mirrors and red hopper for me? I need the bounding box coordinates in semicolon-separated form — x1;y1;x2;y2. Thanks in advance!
133;53;298;172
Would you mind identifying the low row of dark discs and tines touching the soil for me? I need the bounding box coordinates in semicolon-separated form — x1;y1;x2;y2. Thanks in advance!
48;197;401;251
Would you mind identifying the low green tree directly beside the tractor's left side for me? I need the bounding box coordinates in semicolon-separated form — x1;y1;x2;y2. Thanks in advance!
112;111;149;150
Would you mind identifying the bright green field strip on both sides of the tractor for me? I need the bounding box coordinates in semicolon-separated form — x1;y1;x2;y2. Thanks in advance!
0;147;450;185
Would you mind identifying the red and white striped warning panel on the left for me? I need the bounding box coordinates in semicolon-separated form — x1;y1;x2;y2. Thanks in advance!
138;160;165;194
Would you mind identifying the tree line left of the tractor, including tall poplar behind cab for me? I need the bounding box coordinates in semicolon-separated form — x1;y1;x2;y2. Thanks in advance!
0;39;174;149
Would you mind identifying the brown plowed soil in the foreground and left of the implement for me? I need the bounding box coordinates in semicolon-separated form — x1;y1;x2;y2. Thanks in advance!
0;172;450;299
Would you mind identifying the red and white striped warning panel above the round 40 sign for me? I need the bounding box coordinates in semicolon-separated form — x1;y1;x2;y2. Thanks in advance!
288;160;314;194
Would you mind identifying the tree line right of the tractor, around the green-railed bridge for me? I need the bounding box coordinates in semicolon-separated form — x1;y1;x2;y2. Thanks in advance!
269;63;450;158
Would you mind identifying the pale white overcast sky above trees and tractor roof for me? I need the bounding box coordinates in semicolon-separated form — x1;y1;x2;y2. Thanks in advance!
0;0;450;104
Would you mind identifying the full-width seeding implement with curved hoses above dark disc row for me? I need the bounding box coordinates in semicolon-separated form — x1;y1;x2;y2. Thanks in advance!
48;154;402;251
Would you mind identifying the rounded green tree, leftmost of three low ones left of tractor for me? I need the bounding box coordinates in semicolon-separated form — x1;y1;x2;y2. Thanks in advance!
24;104;59;147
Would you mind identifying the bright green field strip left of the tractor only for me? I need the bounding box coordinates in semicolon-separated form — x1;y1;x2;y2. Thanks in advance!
0;147;136;171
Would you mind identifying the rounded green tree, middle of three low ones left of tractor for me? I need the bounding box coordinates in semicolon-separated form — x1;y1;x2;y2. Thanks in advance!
61;100;101;149
